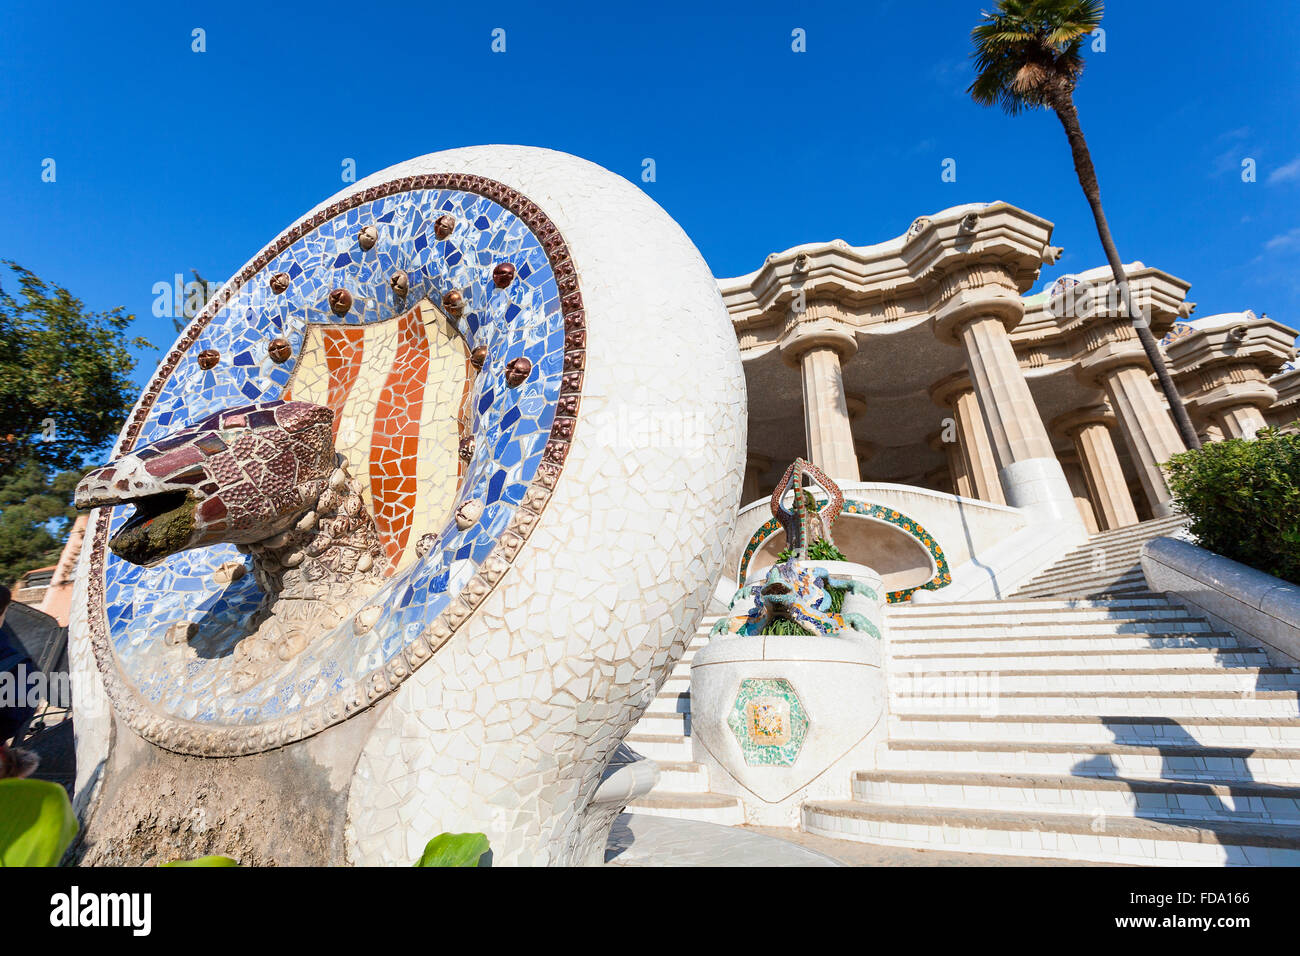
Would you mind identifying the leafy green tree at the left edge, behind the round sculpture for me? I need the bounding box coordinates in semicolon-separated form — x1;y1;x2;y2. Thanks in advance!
0;260;152;584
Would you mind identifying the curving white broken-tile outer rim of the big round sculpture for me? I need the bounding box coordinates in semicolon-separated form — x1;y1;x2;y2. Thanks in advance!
348;147;745;865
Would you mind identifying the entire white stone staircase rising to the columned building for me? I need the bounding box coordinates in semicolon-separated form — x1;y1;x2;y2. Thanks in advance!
802;520;1300;865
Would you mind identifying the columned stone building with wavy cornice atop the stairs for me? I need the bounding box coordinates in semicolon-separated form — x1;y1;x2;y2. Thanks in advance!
719;202;1300;532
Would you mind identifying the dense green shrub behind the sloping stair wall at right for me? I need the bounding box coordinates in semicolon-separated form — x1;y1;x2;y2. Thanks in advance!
1165;428;1300;584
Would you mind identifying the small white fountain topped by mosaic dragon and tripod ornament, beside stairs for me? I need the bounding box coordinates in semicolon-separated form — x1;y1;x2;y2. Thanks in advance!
690;459;887;827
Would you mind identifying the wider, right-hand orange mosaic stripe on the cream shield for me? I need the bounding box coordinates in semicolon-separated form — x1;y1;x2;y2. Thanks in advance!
371;306;429;568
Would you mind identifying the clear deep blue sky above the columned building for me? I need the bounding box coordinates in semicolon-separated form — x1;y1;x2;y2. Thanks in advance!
0;0;1300;390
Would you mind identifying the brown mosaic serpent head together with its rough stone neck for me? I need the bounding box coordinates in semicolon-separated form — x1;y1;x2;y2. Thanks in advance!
75;401;387;689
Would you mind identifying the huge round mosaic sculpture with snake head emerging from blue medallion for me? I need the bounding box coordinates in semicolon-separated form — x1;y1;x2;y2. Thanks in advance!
70;147;745;865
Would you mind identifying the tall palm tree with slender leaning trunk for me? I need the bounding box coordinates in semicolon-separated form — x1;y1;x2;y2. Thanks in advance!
967;0;1201;449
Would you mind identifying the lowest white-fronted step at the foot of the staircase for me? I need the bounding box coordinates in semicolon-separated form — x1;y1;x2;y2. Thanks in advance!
802;800;1300;866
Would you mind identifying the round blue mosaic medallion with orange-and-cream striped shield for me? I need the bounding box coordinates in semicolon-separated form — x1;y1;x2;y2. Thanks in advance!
90;174;585;754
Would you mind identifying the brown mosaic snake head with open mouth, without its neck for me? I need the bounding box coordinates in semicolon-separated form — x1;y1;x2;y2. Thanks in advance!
75;401;335;567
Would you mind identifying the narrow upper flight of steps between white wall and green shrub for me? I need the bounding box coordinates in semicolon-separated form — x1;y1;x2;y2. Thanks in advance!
1011;515;1187;598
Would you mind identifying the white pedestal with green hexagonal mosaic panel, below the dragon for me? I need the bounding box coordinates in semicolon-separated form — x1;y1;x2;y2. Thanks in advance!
690;562;888;827
